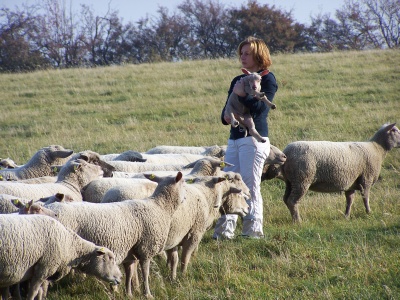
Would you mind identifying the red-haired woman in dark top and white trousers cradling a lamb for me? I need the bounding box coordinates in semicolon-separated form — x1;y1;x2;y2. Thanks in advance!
213;37;278;239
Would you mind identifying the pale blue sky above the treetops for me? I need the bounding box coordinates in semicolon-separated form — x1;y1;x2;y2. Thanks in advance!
0;0;345;25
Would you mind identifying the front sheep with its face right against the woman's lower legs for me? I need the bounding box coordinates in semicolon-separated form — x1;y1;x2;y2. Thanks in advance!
164;172;250;279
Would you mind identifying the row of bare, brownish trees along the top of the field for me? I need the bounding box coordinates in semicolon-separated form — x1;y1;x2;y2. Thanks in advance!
0;0;400;72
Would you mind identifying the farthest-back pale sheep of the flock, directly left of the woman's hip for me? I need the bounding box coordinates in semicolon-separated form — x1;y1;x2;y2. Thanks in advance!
145;145;226;158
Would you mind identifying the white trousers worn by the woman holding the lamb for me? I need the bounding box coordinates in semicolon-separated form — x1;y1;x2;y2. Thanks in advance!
213;136;270;239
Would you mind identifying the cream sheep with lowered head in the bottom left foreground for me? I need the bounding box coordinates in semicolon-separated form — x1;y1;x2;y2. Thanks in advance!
0;215;122;300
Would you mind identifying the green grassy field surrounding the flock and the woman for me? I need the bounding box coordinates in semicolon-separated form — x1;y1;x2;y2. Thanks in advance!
0;50;400;300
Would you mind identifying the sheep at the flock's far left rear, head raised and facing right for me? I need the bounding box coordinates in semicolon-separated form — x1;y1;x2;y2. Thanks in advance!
0;145;73;181
